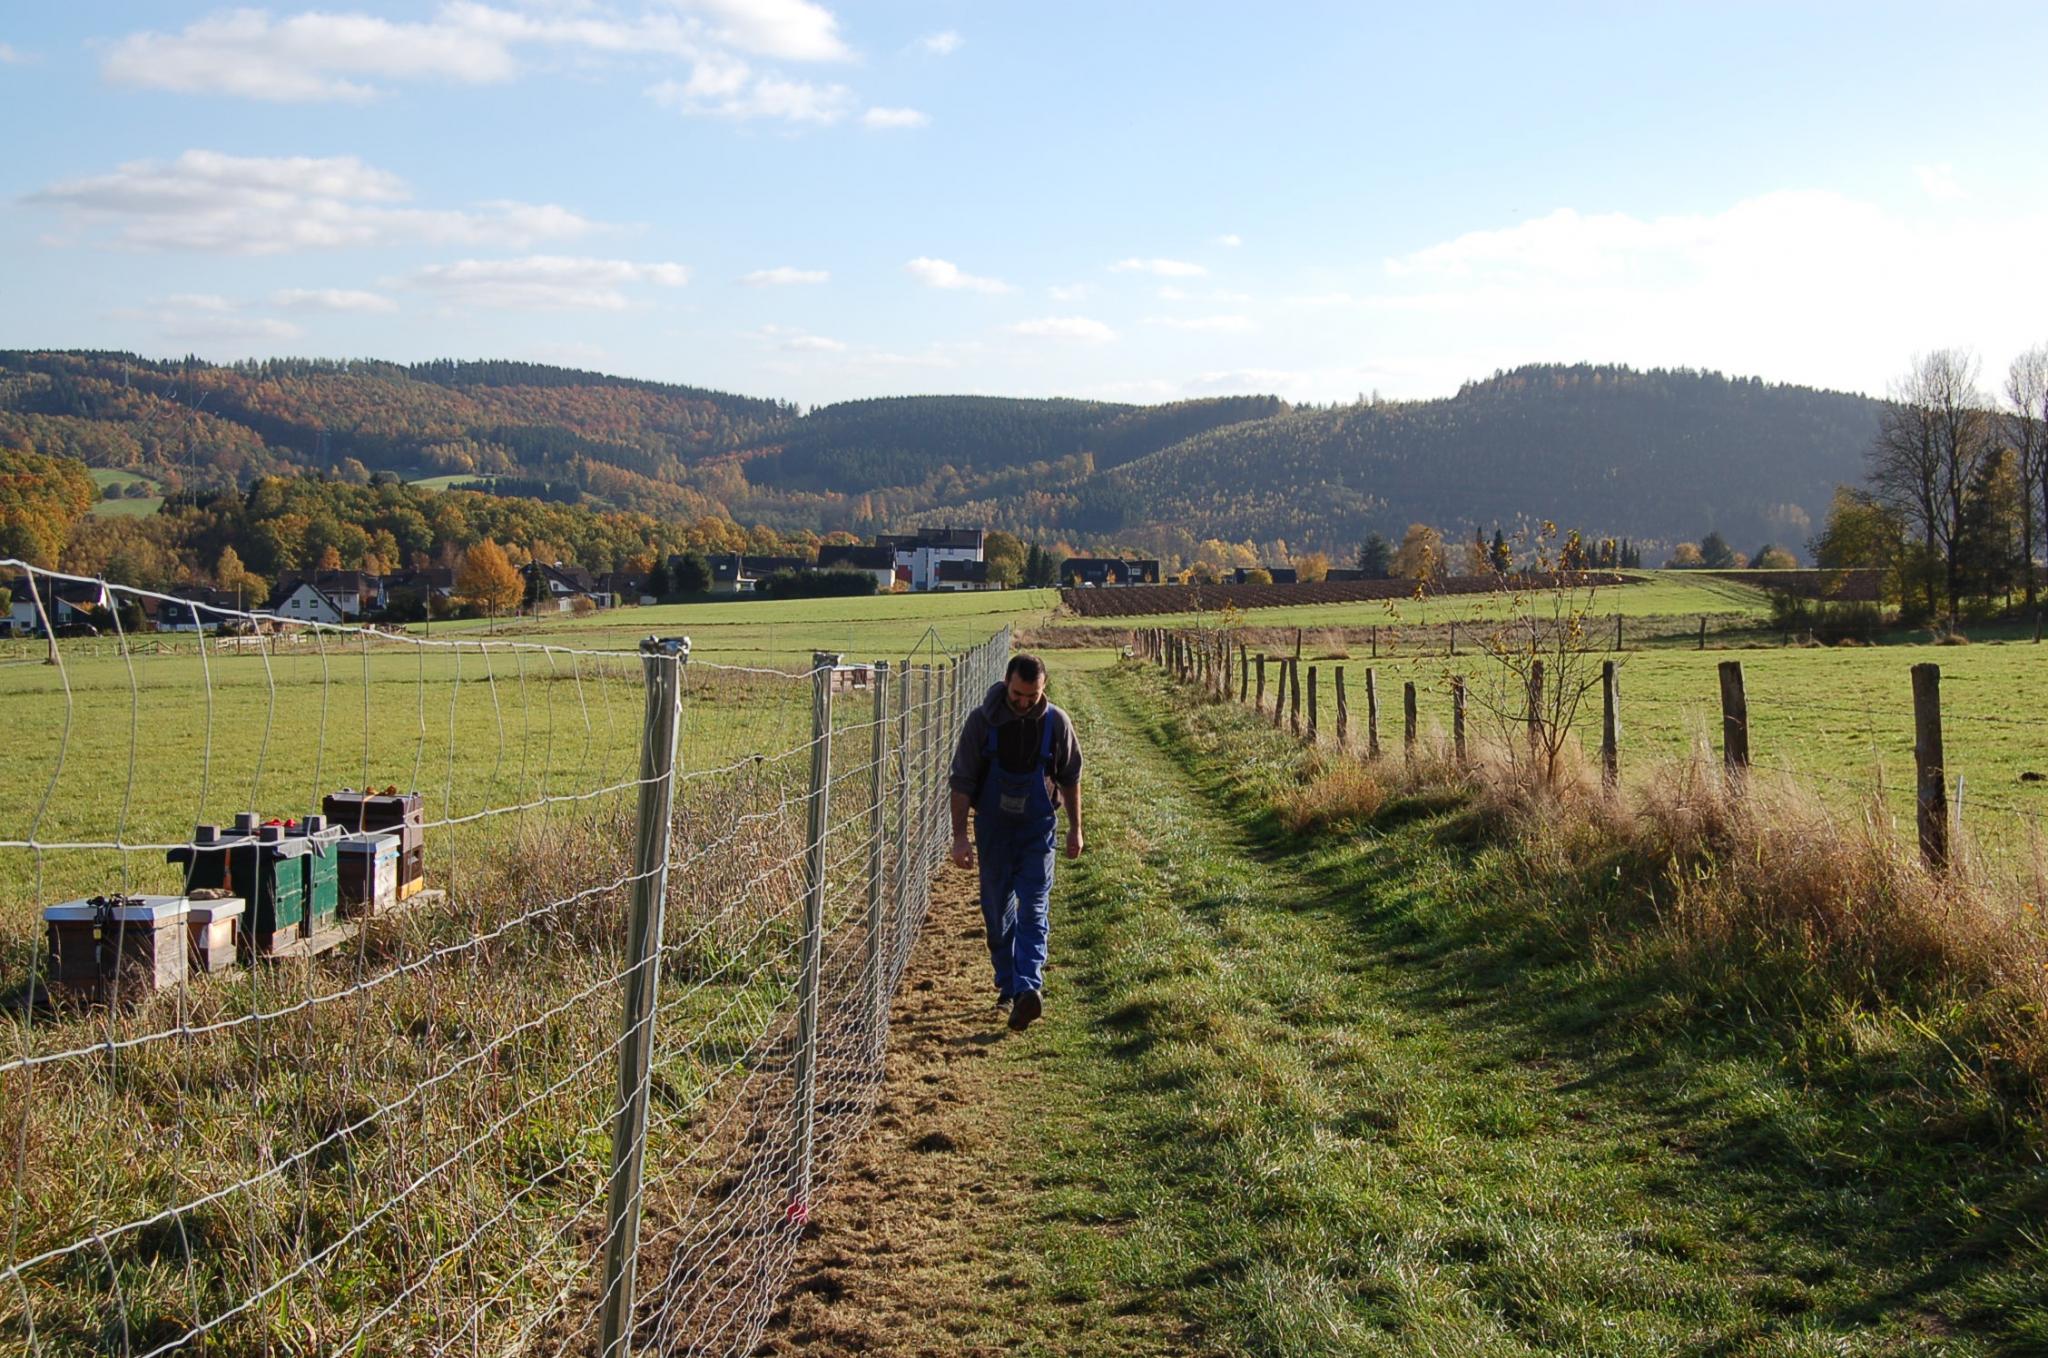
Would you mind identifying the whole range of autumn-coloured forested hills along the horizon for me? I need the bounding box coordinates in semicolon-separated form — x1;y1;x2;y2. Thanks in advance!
0;350;1878;555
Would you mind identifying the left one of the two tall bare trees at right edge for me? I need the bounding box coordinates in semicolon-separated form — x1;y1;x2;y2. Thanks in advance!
1870;348;1993;627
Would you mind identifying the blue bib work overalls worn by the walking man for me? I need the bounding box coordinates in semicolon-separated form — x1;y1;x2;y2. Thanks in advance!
975;713;1055;1000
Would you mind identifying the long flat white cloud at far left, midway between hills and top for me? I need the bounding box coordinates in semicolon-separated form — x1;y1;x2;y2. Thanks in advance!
25;152;598;254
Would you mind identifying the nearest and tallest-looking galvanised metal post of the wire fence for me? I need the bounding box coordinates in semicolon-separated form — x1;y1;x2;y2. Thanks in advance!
598;637;690;1358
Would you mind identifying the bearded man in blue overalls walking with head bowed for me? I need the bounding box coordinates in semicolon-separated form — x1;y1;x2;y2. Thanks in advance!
950;655;1081;1032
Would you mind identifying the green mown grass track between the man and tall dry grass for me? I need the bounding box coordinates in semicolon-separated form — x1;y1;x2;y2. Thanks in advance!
765;668;2048;1358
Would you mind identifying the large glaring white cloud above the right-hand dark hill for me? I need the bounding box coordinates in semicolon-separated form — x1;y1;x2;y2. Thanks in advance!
1358;190;2048;401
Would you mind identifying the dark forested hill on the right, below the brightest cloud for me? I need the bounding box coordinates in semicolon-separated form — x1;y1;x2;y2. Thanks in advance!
1065;367;1878;547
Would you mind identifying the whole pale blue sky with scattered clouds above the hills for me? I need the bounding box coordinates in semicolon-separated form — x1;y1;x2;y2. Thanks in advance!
0;0;2048;404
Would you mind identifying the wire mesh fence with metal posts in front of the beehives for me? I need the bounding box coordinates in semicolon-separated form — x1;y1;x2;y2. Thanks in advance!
0;561;1010;1358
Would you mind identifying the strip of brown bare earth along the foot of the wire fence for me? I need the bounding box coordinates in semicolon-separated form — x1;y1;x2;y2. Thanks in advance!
756;868;1036;1358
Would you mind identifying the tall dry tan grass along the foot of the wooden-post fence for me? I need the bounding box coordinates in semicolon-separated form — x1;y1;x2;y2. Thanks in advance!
1276;737;2048;1110
